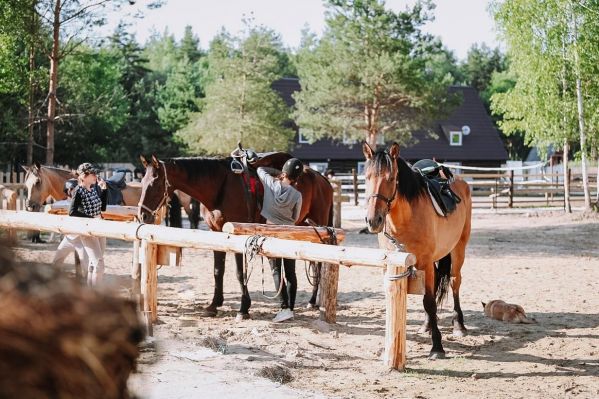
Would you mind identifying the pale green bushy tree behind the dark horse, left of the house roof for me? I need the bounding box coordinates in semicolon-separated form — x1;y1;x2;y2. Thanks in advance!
178;23;293;154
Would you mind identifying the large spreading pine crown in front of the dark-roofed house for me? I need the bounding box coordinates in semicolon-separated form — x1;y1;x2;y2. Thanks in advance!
294;0;454;144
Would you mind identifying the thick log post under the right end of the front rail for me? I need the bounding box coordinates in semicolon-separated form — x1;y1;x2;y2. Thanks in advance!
384;265;408;371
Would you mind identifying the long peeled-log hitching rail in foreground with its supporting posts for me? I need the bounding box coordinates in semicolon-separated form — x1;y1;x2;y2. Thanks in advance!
0;210;416;369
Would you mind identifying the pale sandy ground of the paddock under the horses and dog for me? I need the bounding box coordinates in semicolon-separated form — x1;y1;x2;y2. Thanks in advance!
12;207;599;399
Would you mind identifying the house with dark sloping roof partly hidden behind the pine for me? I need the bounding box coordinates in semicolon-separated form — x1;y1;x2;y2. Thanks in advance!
273;78;508;173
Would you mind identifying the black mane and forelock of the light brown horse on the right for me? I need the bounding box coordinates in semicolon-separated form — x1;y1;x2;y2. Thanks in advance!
368;150;426;202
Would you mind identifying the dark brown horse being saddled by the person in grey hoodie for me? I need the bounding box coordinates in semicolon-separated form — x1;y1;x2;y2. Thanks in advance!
139;153;333;318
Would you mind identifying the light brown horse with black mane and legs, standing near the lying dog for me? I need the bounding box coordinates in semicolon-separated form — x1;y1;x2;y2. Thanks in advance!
363;143;472;359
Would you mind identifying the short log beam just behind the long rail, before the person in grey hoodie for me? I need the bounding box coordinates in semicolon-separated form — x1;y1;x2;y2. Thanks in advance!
223;222;345;243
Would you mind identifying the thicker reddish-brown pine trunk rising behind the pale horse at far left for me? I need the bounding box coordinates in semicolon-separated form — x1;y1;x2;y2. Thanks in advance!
46;0;60;165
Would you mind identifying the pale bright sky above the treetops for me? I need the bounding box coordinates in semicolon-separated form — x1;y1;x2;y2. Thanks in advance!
118;0;499;59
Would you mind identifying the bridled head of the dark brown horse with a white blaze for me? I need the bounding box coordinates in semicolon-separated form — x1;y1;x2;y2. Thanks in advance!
138;155;173;223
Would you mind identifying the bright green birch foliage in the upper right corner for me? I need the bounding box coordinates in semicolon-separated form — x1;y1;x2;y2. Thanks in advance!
491;0;599;159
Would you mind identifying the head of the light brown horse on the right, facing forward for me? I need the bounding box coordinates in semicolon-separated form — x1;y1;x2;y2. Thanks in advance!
362;143;399;233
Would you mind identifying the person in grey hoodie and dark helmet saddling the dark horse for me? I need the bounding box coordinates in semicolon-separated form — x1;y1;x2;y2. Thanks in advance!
258;158;304;323
